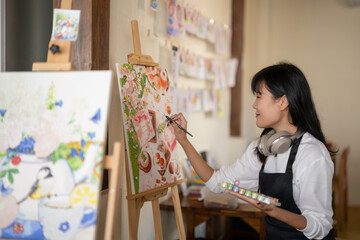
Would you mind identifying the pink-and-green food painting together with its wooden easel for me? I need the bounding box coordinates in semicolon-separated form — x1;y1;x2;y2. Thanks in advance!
116;20;186;240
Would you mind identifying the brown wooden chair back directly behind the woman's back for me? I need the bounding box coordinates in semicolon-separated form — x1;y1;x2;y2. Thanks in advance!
332;147;350;230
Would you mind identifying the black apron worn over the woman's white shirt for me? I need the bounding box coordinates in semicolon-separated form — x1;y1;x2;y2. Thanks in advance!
259;137;335;240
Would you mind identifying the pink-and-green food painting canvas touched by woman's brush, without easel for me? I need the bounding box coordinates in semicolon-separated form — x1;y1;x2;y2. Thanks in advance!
116;64;182;194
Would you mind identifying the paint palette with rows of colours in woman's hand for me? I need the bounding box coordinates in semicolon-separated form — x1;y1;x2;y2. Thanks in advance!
221;180;281;206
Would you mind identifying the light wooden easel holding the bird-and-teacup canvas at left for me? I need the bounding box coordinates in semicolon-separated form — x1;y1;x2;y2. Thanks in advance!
32;0;121;240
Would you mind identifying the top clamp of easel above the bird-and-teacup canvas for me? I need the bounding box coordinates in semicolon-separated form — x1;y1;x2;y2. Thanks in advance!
32;0;74;71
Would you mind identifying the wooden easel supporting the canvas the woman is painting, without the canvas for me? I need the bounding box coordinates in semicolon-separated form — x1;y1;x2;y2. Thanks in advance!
123;20;186;240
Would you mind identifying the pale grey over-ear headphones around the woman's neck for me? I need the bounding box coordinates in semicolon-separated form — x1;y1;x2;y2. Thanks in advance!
258;129;304;156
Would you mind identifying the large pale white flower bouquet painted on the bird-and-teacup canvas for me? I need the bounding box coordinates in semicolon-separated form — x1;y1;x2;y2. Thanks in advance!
0;78;105;158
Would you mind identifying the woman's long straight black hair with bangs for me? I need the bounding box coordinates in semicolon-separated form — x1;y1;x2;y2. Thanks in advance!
251;62;335;162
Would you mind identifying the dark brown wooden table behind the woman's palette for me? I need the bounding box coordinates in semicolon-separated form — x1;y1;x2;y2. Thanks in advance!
160;197;266;239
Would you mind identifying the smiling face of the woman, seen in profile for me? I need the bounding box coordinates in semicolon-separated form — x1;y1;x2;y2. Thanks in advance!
253;82;283;130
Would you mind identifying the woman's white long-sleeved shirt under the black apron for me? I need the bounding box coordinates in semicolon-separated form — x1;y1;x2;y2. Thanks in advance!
205;133;334;239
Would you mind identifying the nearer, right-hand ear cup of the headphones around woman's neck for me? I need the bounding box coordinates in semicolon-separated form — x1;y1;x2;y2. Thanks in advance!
267;131;293;154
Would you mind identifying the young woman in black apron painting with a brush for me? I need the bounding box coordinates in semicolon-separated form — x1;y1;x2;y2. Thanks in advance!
170;63;334;240
